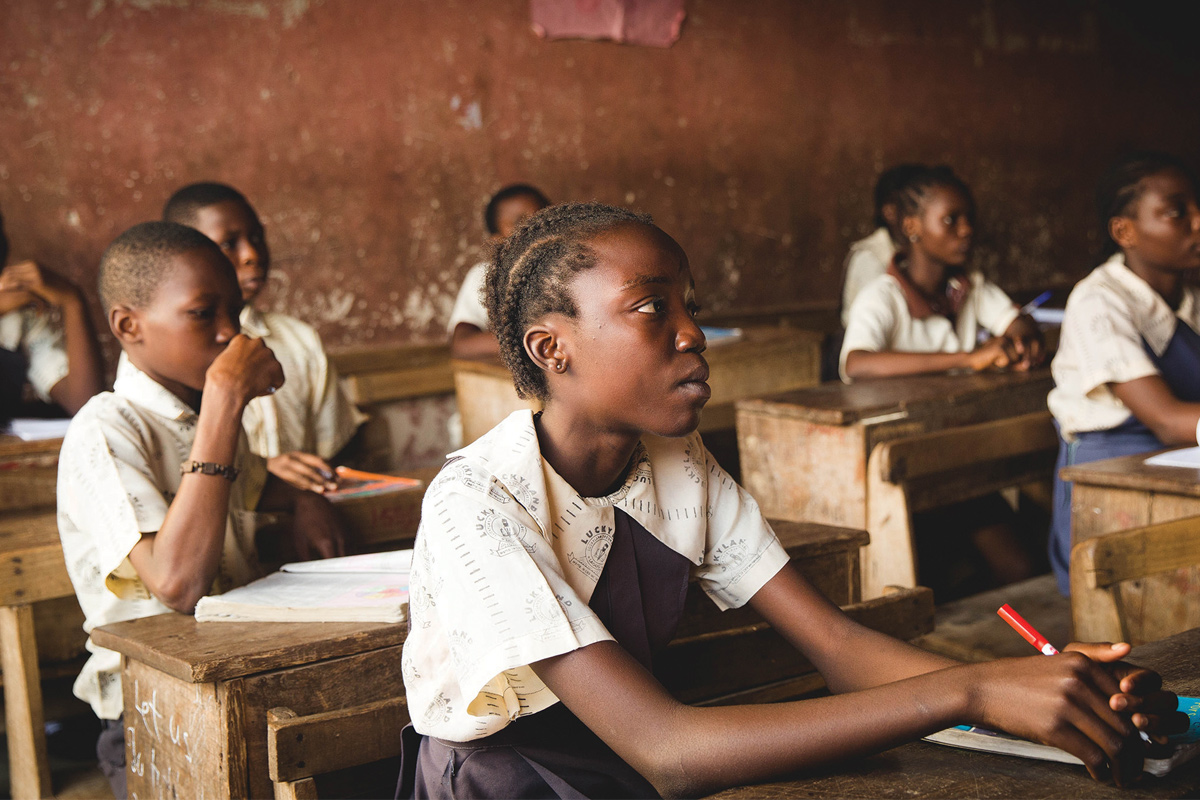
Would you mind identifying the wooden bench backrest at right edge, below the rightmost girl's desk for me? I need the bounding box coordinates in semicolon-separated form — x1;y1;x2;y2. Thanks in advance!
1070;517;1200;644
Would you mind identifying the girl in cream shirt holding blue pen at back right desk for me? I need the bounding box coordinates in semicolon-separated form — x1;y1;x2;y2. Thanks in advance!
840;167;1043;383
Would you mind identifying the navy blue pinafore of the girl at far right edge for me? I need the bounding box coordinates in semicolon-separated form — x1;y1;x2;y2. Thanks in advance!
1050;320;1200;595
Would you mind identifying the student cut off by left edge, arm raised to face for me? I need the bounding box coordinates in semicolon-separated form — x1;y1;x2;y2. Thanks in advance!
0;206;104;419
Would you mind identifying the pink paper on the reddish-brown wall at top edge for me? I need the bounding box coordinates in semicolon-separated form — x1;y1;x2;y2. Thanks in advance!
529;0;685;47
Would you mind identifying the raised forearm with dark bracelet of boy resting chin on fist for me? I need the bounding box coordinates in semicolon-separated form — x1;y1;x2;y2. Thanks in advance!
131;392;244;613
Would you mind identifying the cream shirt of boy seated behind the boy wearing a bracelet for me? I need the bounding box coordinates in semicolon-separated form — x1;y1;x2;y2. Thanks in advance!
241;306;367;458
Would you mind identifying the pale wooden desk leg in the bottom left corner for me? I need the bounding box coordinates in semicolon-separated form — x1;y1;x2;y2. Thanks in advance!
0;606;52;800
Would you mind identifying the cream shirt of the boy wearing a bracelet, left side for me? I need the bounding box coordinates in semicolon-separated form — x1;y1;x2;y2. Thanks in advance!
58;362;266;720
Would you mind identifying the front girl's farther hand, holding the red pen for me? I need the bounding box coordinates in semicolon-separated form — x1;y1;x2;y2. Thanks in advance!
1066;642;1189;744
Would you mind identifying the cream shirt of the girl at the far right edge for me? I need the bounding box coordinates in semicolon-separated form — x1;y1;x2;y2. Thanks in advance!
1046;253;1200;440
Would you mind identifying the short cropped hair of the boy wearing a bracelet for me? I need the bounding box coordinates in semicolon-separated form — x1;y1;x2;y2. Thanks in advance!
97;222;224;311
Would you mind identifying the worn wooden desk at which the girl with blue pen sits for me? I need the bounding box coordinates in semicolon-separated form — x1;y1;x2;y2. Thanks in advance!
737;369;1054;597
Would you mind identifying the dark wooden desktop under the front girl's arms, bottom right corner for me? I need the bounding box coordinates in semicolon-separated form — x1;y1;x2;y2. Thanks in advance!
712;630;1200;800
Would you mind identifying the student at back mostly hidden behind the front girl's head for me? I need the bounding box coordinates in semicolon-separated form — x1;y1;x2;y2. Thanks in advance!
446;184;550;359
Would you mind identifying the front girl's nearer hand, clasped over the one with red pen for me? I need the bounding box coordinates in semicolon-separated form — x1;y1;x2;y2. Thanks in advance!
967;645;1144;786
